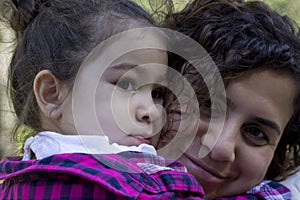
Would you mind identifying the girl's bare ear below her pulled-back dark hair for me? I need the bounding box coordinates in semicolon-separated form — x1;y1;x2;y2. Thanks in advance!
33;70;63;120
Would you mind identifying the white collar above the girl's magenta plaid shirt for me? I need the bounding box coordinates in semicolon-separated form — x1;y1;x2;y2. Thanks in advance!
23;131;157;160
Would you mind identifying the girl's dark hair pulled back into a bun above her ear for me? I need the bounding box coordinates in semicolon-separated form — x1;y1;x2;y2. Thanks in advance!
0;0;154;144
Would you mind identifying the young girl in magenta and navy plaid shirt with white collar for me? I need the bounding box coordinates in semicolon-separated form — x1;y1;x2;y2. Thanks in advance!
0;0;202;199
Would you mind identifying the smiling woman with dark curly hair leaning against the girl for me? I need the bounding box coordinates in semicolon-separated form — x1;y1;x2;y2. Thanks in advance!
160;0;300;199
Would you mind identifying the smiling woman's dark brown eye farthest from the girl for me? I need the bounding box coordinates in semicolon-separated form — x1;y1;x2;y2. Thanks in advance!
242;125;269;146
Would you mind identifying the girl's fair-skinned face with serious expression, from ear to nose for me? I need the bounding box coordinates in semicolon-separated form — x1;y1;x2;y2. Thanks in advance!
55;29;168;146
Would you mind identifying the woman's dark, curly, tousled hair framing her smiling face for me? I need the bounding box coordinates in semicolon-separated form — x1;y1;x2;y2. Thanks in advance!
165;0;300;179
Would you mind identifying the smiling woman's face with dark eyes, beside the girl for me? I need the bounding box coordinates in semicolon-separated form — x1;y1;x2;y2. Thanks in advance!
170;68;296;198
